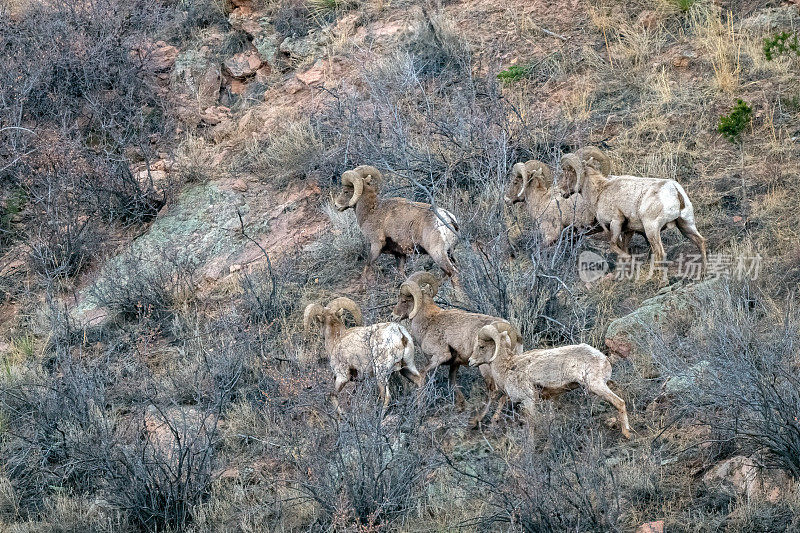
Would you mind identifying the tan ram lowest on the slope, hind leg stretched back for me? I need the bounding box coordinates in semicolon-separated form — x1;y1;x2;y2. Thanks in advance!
469;334;631;438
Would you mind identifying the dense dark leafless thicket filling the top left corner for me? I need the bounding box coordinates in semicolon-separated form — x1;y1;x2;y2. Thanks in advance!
0;0;174;245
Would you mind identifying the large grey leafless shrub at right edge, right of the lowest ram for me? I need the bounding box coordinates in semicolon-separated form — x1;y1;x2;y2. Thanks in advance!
656;281;800;477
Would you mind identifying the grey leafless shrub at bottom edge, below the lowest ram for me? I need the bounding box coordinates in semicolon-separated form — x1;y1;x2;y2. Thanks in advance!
445;417;623;532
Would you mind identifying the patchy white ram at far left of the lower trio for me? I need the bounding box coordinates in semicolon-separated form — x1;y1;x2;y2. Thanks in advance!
303;297;422;410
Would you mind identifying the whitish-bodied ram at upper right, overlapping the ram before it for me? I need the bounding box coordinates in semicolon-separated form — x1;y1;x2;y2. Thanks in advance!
561;147;707;273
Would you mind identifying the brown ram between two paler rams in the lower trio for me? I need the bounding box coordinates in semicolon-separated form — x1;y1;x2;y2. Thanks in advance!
392;272;522;412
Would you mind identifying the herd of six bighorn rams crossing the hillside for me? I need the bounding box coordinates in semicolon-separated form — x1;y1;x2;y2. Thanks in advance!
303;147;706;438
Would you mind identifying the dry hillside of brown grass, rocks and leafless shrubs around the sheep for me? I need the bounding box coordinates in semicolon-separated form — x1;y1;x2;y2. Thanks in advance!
0;0;800;532
